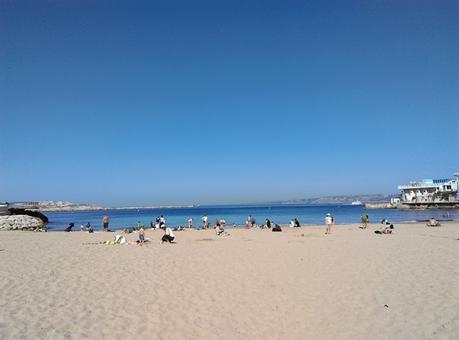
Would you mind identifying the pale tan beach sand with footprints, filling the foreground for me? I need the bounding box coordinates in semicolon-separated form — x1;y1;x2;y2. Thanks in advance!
0;222;459;339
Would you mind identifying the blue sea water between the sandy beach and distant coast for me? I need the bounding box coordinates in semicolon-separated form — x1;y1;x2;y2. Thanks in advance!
45;205;459;230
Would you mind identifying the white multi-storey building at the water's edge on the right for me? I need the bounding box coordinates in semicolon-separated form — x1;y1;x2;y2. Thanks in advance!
398;173;459;204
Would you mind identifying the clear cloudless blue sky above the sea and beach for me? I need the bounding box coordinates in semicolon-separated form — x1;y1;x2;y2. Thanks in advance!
0;0;459;206
